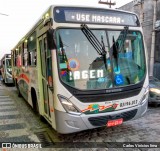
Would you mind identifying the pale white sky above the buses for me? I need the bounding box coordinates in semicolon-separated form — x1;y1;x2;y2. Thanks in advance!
0;0;132;60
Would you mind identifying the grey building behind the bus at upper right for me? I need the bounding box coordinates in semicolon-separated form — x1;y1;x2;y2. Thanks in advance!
118;0;160;79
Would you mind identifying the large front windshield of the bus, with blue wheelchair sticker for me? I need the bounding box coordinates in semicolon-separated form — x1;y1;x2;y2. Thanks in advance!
56;29;146;90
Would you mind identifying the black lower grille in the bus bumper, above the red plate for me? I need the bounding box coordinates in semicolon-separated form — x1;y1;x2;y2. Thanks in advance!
88;109;137;126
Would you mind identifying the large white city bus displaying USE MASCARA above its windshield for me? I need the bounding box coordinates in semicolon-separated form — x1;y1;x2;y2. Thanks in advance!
12;5;149;134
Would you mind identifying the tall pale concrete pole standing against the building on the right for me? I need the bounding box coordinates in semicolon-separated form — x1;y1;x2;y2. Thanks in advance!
149;0;157;76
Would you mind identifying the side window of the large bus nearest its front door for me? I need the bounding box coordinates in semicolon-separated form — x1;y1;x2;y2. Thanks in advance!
28;32;37;66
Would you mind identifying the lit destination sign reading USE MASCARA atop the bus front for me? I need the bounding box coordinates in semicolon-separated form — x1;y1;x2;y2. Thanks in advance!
54;7;139;26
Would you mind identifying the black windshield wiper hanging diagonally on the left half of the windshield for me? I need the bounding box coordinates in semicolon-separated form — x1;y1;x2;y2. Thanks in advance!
81;24;107;70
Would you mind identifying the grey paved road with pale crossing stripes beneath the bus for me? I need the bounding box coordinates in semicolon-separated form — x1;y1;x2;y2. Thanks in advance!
0;82;160;151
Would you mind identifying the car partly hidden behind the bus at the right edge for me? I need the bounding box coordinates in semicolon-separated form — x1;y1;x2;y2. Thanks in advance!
148;76;160;106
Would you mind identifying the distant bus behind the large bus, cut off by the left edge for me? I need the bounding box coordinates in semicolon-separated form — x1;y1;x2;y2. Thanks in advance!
1;54;13;84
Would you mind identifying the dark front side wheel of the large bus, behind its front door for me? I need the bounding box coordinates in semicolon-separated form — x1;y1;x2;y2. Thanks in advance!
31;89;39;114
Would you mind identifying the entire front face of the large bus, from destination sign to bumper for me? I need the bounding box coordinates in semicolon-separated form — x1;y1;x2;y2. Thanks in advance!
49;7;148;133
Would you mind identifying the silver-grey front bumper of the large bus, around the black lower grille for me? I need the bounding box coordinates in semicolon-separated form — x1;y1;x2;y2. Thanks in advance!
55;101;148;134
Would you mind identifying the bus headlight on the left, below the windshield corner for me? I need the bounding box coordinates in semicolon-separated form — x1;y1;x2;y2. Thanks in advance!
58;95;81;115
